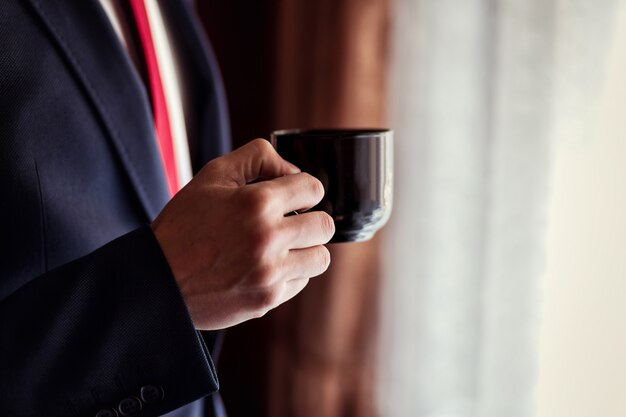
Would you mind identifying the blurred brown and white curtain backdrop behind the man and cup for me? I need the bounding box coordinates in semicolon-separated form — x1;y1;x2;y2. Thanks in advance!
198;0;626;417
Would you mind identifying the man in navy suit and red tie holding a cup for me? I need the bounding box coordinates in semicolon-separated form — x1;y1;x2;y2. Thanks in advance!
0;0;334;417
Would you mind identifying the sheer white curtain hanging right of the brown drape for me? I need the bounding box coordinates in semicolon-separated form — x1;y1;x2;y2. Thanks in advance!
377;0;626;417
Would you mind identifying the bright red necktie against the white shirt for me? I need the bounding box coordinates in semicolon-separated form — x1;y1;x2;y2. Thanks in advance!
130;0;179;195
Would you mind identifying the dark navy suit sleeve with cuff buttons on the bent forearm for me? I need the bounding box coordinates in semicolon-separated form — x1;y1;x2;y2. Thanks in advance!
0;226;218;417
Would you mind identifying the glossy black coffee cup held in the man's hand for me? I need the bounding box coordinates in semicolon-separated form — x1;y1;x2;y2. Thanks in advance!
271;129;393;243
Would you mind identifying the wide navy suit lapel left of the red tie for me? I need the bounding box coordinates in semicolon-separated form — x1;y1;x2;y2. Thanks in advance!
29;0;169;219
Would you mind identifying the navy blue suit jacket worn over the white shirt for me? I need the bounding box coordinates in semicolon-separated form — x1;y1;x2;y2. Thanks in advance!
0;0;229;417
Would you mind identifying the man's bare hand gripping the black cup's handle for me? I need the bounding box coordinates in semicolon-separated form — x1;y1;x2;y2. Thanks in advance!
152;139;335;330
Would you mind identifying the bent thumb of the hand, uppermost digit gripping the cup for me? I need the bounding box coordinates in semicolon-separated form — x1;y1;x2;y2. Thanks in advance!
204;139;300;186
